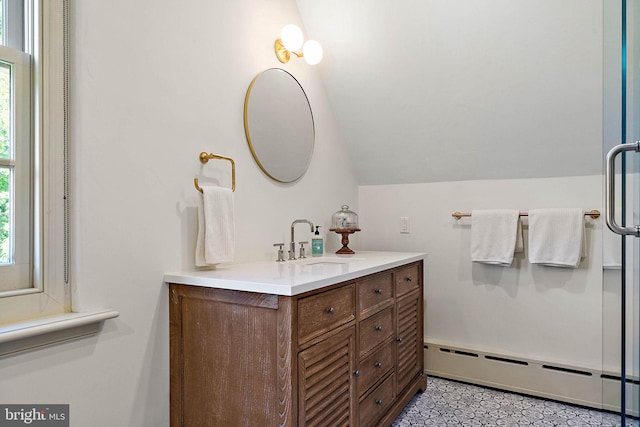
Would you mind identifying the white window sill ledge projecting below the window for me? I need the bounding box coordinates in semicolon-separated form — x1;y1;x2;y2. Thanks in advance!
0;310;119;357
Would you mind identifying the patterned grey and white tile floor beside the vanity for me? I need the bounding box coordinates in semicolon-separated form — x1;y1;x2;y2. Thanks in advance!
392;376;639;427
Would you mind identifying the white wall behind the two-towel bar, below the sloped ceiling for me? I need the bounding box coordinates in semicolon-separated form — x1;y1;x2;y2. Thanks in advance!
359;175;604;370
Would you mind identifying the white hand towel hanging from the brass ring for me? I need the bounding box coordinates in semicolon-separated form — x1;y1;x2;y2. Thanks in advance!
196;186;235;267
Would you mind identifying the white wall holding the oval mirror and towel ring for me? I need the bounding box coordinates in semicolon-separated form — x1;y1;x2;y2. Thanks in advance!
0;0;357;427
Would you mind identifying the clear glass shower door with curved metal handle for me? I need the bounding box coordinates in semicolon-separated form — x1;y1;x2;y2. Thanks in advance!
602;0;640;425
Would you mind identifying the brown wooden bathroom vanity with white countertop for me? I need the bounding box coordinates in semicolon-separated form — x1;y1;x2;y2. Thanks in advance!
164;252;426;427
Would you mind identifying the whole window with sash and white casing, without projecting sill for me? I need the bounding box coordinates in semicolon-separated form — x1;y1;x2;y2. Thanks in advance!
0;0;71;325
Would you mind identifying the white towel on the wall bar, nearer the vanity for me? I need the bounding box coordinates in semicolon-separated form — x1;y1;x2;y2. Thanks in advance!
470;209;523;267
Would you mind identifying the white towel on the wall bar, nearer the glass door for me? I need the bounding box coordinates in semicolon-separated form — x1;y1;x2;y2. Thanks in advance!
529;208;585;268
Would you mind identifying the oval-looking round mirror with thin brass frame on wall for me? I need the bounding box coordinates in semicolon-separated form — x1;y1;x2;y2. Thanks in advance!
244;68;315;182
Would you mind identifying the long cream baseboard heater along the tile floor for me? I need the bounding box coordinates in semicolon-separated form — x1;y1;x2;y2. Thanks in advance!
424;342;640;416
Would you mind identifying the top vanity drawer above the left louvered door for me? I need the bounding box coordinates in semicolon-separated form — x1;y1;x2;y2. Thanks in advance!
298;284;356;343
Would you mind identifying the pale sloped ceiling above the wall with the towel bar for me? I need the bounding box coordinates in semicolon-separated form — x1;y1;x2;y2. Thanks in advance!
297;0;603;185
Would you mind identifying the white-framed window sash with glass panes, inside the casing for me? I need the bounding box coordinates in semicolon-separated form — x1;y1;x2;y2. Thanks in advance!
0;0;36;294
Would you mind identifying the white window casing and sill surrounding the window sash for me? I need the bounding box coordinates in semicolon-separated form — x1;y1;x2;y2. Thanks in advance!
0;0;118;356
